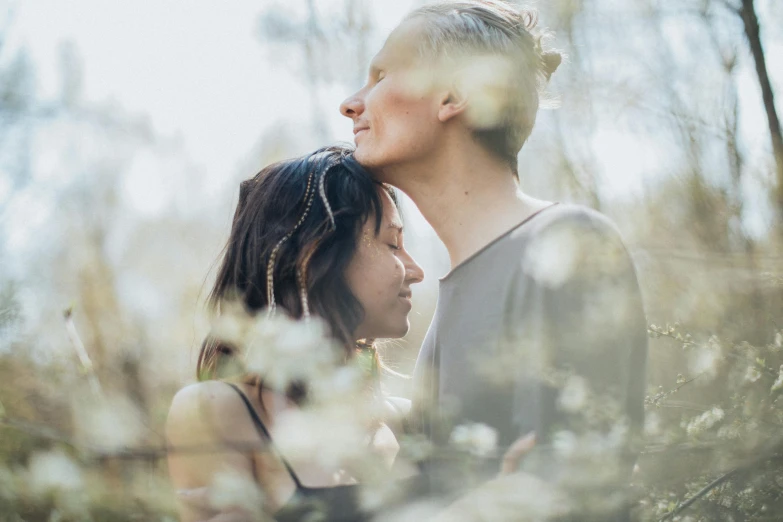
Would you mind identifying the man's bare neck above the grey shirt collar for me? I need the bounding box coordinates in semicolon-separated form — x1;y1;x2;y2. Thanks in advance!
384;147;549;268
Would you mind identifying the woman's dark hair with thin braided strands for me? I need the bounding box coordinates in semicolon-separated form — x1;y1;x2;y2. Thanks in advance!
196;146;397;400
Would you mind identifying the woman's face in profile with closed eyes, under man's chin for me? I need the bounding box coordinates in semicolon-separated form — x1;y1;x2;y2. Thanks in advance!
345;187;424;339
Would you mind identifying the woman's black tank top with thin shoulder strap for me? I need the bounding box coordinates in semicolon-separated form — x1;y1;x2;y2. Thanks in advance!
226;383;372;522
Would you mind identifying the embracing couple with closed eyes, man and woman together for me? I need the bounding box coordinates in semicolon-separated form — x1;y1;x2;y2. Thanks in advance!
166;0;647;522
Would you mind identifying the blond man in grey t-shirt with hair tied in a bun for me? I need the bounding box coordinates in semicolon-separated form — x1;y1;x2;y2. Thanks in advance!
341;0;647;520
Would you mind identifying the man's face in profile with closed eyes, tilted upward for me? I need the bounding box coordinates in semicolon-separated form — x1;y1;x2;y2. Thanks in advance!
340;20;442;176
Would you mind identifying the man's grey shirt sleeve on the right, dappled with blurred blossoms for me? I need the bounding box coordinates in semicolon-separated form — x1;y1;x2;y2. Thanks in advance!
506;210;647;489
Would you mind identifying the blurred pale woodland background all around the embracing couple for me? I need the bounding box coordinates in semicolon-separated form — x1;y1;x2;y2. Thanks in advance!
0;0;783;520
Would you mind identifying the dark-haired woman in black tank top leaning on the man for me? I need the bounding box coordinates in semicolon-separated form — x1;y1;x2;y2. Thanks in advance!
166;147;423;521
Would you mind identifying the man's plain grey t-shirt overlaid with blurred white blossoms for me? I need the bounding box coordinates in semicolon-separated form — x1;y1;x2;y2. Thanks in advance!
411;204;647;504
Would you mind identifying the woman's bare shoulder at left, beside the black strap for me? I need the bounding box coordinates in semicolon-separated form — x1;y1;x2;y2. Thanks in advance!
166;381;255;443
